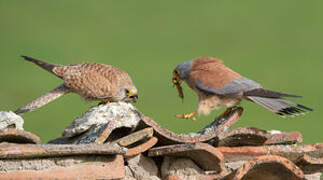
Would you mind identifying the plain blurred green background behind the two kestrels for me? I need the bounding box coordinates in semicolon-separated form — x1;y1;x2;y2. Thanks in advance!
0;0;323;143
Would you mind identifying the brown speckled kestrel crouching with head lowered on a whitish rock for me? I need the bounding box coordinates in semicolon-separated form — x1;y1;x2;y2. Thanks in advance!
15;56;138;114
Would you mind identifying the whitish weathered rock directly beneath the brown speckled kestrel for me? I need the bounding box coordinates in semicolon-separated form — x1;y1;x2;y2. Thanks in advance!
63;102;141;143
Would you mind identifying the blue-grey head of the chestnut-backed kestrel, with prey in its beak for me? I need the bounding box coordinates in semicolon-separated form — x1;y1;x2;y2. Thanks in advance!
172;61;192;99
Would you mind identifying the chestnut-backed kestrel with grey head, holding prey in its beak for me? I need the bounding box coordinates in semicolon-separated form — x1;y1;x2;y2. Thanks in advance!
173;57;312;120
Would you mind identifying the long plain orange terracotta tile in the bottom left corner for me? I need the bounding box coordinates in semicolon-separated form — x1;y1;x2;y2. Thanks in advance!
0;155;125;180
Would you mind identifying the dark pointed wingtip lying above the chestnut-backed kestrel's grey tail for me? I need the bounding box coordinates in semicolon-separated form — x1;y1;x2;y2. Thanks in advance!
243;88;302;98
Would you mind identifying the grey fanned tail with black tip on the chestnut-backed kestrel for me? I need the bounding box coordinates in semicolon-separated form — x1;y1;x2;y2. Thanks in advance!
247;96;313;117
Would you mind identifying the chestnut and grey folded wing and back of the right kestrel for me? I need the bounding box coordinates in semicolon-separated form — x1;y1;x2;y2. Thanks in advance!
190;58;261;95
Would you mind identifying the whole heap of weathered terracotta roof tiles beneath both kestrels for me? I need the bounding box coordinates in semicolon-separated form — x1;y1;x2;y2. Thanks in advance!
0;105;323;180
